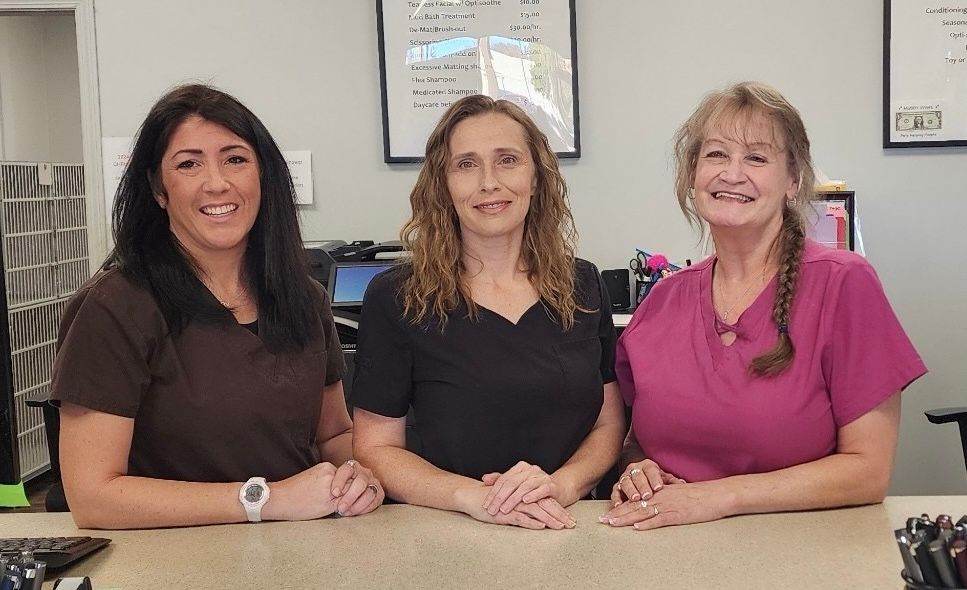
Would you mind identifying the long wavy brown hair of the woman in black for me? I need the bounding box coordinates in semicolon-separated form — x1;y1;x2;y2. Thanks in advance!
400;95;579;330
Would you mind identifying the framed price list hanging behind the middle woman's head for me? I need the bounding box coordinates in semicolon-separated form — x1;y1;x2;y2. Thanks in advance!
376;0;581;163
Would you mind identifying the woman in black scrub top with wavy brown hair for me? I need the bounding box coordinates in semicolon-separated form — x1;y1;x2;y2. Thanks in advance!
352;96;624;529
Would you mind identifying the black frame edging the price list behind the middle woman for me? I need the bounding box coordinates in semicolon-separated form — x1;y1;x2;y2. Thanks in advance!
376;0;581;164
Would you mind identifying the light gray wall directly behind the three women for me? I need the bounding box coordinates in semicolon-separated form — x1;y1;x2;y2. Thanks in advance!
95;0;967;494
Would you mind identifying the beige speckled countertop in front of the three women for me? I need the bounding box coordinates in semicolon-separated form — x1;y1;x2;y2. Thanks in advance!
0;496;967;590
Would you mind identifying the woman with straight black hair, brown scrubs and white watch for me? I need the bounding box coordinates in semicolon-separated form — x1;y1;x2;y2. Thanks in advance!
52;85;383;528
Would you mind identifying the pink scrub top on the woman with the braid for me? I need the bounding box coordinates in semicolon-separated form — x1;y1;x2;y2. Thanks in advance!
615;240;927;481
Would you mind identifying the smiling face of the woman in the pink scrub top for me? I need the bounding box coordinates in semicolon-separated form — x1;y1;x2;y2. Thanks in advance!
693;114;799;237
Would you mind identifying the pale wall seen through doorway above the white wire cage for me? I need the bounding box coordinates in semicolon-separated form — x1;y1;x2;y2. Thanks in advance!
0;14;83;162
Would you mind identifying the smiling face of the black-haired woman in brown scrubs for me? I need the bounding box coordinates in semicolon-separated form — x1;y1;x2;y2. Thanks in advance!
155;116;261;260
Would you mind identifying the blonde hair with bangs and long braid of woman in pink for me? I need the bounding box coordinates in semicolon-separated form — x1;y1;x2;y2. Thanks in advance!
675;82;816;376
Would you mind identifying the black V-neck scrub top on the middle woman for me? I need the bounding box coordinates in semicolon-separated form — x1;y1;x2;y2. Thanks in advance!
352;259;616;479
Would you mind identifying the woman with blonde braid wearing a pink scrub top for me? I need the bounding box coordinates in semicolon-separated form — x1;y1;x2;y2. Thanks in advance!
601;82;926;529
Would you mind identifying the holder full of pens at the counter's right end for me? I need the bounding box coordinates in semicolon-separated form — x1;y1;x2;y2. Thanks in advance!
894;514;967;590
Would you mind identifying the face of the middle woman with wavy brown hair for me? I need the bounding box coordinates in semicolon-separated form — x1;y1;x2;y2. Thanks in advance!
446;113;537;243
